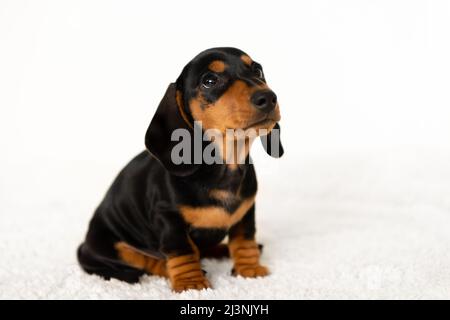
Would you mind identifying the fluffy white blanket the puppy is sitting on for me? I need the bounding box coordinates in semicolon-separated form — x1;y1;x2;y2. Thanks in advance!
0;148;450;299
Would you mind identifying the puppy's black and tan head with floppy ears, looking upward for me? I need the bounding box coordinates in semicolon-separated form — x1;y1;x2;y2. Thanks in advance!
146;48;283;175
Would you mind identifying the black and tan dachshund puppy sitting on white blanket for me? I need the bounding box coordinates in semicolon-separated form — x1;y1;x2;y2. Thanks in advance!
78;48;283;291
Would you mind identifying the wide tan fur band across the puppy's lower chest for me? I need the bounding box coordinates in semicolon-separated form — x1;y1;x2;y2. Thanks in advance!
179;197;255;229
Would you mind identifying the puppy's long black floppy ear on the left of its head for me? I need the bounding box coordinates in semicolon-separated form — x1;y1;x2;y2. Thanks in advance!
145;83;197;176
